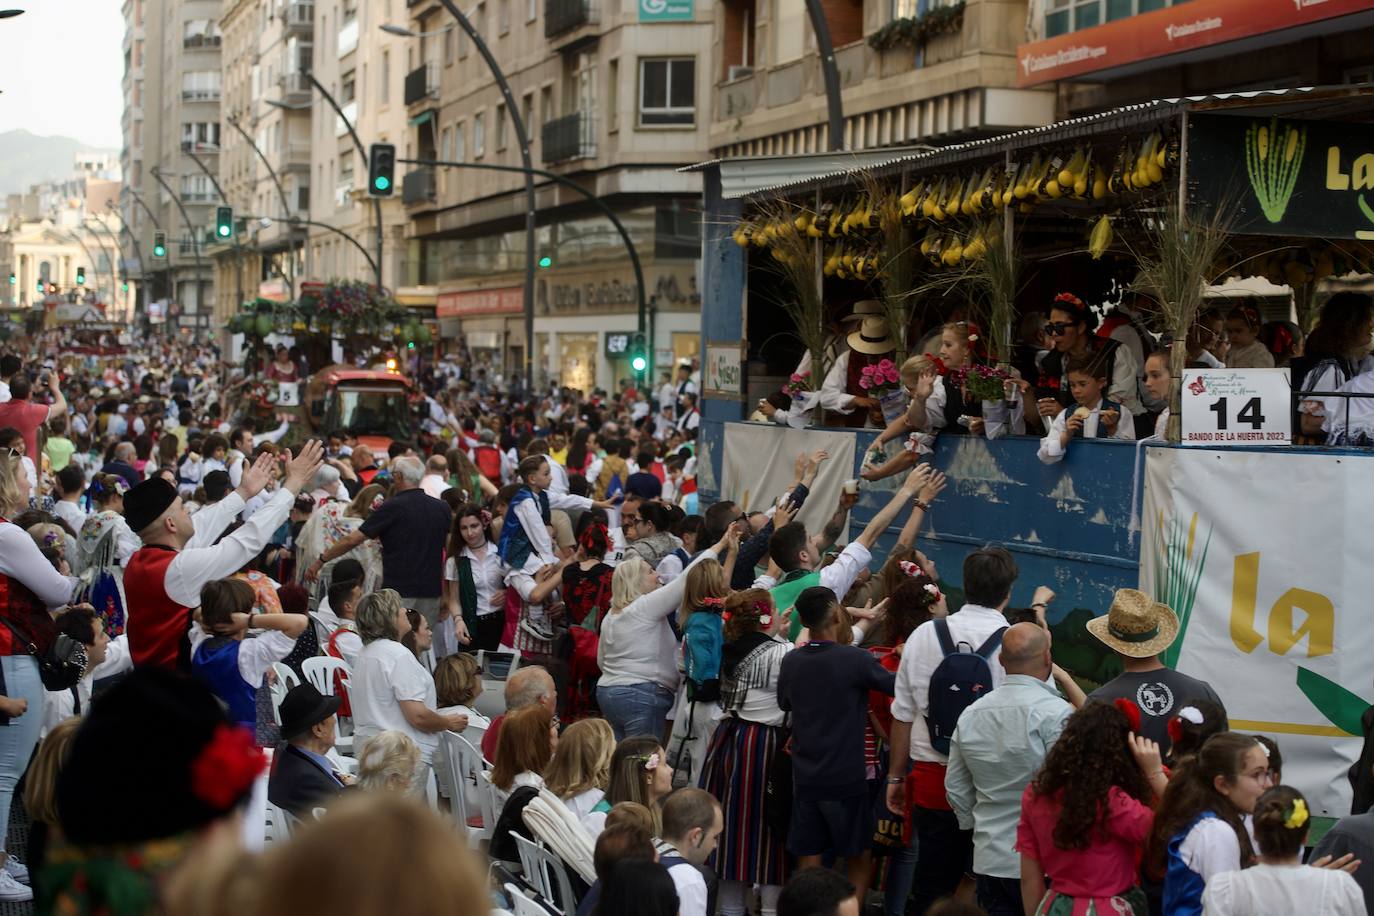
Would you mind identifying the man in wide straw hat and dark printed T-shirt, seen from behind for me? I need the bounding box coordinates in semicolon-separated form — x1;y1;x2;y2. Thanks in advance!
1088;588;1228;754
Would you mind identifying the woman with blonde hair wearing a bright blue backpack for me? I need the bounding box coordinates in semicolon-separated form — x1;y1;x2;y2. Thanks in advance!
668;560;730;786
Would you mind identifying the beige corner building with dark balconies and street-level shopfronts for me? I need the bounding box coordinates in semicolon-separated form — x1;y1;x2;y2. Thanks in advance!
401;0;717;390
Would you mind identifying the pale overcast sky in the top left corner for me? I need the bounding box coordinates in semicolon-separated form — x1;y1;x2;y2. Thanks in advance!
0;0;124;150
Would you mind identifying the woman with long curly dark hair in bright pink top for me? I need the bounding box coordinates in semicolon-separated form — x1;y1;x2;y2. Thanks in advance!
1015;699;1169;916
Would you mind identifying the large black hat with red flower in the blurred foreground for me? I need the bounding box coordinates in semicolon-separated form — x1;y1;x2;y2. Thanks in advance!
56;667;265;846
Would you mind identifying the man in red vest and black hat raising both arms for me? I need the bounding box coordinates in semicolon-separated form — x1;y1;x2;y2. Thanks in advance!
124;439;324;670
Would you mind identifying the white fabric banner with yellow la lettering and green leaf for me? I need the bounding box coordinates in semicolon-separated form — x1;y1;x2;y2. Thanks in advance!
1140;448;1374;817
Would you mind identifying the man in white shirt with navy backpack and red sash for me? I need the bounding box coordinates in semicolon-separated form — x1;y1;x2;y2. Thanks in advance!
888;547;1017;913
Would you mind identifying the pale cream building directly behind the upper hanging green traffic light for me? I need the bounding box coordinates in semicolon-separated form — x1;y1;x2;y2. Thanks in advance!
309;0;405;293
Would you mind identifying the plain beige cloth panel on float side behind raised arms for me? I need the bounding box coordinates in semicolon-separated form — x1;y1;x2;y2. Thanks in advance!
720;423;855;544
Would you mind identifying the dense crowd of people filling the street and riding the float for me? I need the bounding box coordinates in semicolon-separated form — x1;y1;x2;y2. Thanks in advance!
0;306;1374;916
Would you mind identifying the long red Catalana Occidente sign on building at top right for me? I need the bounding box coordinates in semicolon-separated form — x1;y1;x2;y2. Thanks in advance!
1017;0;1369;88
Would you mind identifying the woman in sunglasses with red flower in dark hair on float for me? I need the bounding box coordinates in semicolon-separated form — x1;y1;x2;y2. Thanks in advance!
1036;293;1145;427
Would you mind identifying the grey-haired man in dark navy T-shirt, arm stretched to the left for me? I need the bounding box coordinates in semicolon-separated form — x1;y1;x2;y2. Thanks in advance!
305;456;458;656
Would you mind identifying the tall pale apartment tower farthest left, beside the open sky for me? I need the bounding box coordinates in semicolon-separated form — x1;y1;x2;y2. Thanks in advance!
120;0;221;327
